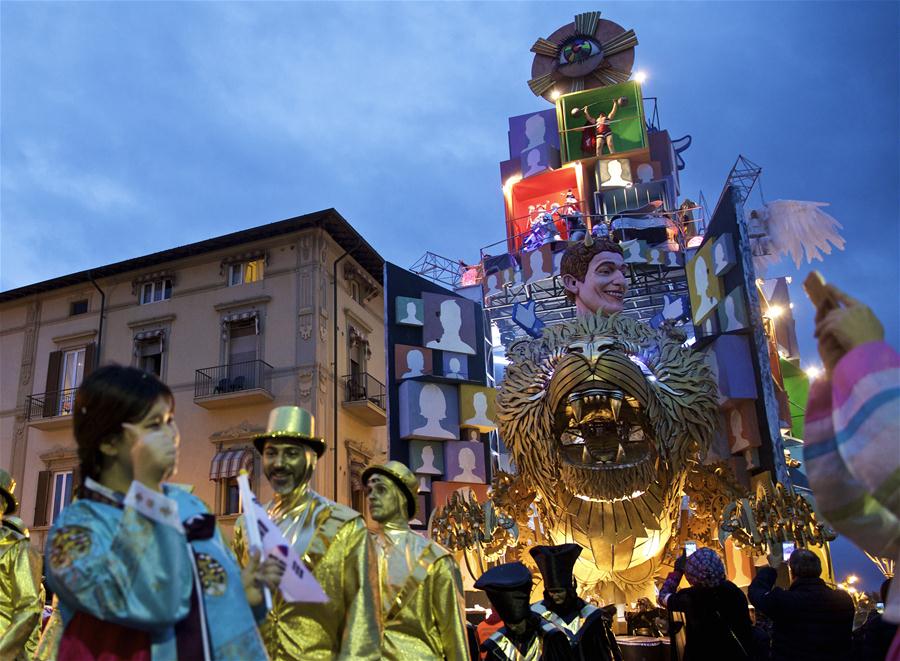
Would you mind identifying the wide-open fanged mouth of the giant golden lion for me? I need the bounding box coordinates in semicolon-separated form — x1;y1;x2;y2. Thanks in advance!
554;387;658;500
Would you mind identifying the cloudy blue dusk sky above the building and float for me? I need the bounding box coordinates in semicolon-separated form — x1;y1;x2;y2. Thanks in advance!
0;2;900;584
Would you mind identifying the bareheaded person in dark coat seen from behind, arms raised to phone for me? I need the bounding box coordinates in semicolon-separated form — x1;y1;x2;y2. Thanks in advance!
748;549;854;661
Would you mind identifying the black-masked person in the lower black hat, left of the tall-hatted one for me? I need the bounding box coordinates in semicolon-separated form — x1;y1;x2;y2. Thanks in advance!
475;562;572;661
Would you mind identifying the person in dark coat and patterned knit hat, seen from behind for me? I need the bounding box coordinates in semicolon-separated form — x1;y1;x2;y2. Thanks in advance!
659;547;755;661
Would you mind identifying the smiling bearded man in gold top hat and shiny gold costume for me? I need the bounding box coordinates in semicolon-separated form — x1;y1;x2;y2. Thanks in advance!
234;406;381;661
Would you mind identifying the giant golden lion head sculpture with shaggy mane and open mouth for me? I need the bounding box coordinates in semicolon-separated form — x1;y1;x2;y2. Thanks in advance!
497;313;717;601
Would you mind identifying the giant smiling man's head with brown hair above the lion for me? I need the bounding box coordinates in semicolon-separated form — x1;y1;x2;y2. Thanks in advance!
559;239;628;316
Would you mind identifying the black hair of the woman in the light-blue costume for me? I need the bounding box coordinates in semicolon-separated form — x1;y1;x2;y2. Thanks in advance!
72;365;175;479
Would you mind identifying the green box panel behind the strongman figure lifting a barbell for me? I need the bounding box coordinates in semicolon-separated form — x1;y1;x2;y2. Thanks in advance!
556;80;648;163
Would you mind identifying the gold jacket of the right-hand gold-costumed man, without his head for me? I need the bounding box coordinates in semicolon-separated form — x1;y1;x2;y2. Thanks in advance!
372;524;469;661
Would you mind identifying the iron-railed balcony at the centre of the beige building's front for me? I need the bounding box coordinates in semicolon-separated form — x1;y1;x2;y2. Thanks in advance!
194;360;275;409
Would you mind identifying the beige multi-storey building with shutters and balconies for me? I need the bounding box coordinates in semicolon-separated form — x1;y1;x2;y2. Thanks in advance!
0;209;387;548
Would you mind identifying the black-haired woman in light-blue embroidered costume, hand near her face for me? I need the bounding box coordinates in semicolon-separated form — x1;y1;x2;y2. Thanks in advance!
45;365;283;661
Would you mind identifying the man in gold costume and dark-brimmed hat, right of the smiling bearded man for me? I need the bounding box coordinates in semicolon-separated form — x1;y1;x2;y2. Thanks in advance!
362;461;469;661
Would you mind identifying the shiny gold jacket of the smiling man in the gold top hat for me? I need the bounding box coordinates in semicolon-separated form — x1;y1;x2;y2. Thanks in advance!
234;487;381;661
